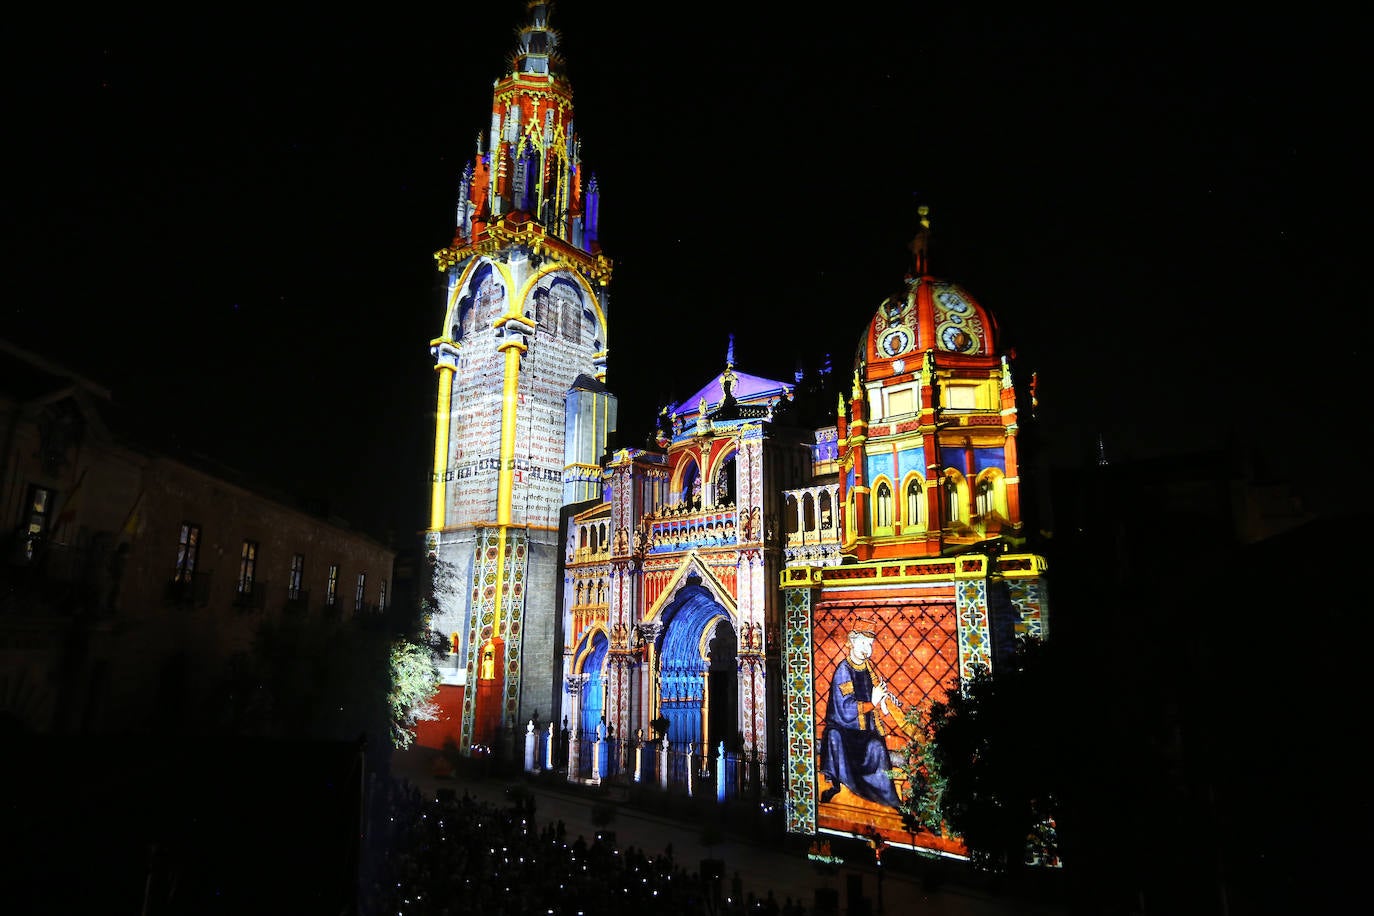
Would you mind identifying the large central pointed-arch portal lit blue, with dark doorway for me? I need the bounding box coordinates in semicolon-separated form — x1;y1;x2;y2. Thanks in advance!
658;575;738;748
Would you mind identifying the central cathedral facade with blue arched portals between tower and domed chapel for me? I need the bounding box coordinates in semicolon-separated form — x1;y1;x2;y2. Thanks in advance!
562;347;811;776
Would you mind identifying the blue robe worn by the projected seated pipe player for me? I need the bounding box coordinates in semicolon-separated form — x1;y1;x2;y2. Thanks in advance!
820;658;901;808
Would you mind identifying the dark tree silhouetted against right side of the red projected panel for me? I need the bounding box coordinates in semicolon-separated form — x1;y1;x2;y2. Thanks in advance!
926;640;1063;872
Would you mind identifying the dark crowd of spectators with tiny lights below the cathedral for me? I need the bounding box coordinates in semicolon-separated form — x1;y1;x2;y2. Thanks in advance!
361;780;811;916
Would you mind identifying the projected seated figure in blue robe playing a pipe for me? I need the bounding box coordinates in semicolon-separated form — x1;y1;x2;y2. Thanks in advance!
820;621;900;808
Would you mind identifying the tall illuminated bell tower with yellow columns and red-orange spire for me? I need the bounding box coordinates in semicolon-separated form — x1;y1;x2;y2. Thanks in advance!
427;3;616;753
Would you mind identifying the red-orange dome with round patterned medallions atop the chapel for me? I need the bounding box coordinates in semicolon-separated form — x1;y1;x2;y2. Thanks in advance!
855;276;998;379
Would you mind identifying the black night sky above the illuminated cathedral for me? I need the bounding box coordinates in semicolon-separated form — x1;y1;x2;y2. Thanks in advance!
0;1;1367;537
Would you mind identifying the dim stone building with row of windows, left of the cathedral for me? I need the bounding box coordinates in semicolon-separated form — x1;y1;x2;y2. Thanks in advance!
0;343;396;737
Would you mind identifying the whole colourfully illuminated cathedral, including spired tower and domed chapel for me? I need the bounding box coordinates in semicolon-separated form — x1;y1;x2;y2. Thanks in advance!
430;3;1047;851
